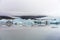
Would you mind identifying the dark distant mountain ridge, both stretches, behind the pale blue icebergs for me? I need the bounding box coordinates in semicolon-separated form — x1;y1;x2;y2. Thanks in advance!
0;16;46;19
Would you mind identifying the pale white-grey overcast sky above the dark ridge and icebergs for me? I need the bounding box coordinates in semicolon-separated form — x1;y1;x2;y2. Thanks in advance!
0;0;60;16
